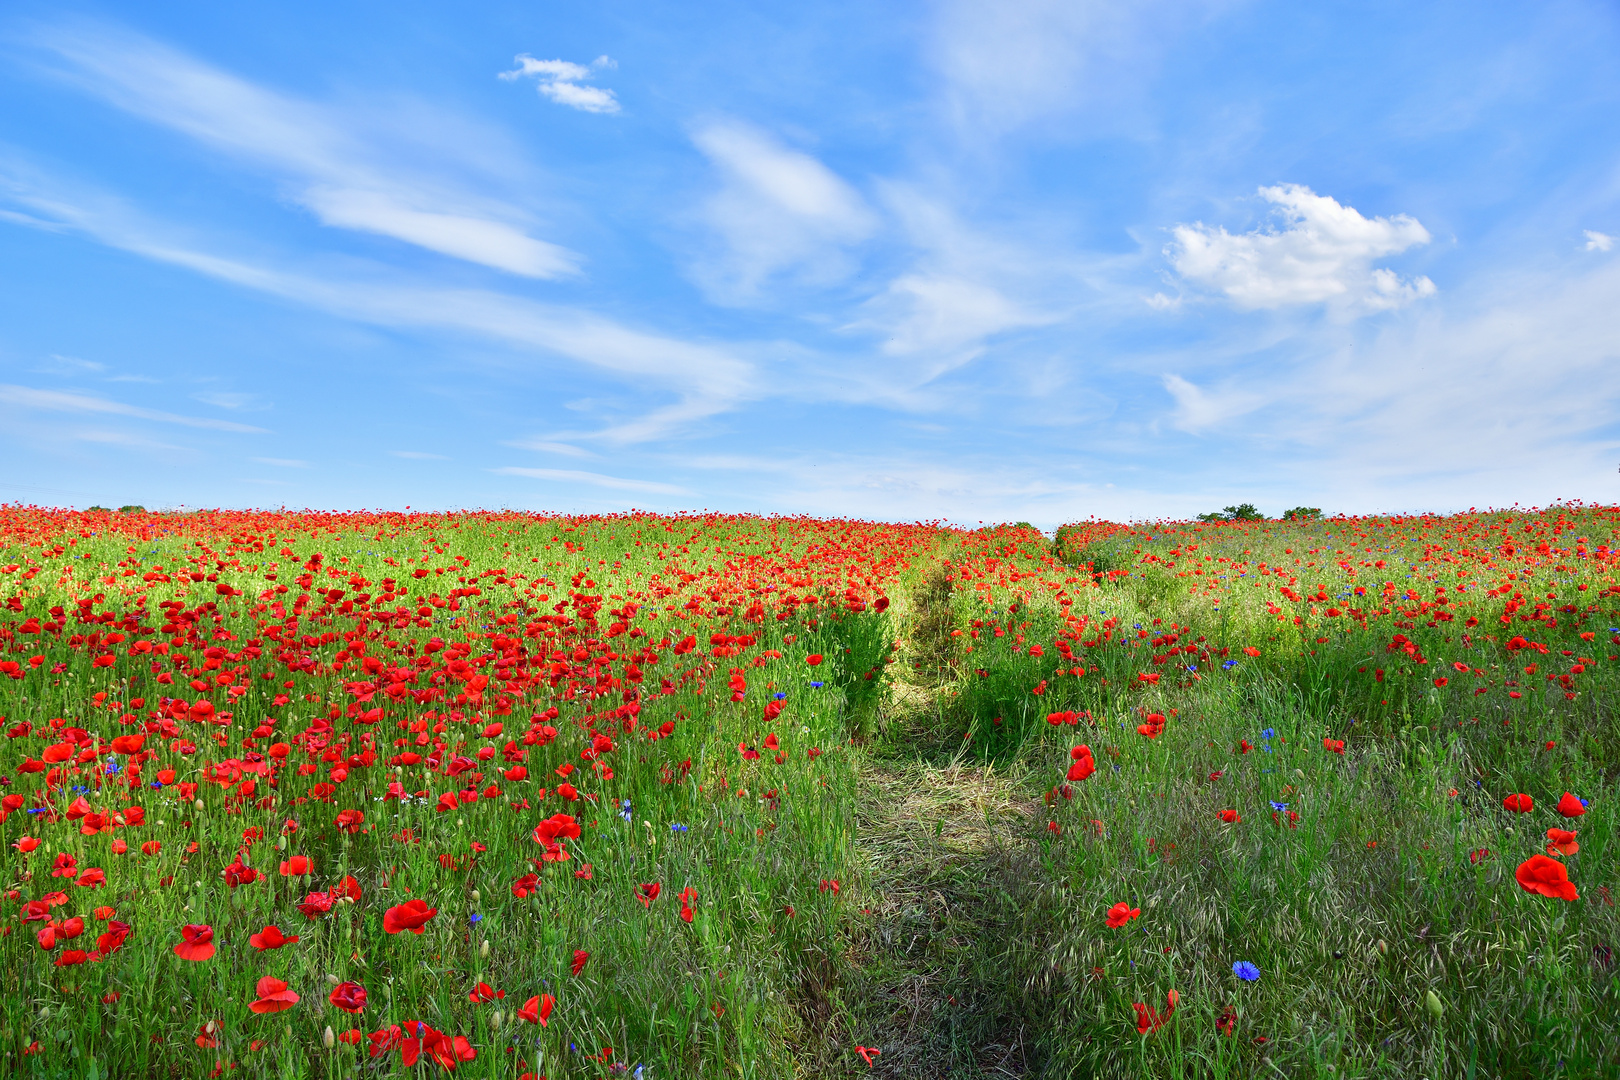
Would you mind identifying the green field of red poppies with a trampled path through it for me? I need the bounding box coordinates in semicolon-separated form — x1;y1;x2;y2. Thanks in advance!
0;504;1620;1080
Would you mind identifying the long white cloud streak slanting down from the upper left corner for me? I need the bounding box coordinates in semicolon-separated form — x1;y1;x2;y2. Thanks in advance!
22;19;580;279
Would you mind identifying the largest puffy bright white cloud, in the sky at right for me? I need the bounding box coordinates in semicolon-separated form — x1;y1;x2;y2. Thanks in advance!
1165;185;1435;311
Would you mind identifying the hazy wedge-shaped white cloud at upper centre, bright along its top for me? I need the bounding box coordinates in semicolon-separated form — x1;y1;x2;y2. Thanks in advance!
692;121;878;301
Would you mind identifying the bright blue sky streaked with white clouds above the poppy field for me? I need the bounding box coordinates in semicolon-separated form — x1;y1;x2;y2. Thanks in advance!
0;0;1620;526
